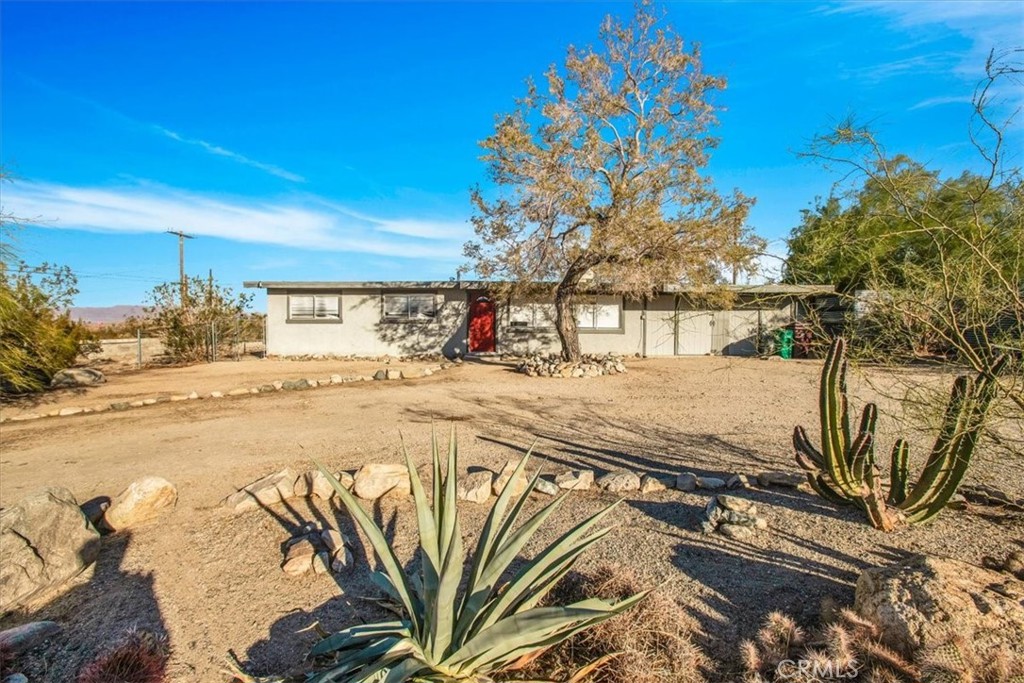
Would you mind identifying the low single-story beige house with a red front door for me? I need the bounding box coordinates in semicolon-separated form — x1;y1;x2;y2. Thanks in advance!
245;281;834;357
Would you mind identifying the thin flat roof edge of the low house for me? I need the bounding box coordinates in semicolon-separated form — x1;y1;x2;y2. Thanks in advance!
242;280;836;296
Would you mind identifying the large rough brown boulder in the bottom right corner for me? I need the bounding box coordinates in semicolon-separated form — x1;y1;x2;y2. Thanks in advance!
854;555;1024;657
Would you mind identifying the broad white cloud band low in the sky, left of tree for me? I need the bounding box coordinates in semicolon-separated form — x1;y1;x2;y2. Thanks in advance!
4;182;471;261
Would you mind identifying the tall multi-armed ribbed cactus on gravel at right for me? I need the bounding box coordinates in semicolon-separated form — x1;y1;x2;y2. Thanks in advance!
793;338;1007;531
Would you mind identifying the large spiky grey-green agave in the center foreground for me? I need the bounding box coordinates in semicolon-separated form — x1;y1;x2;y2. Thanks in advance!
310;428;647;683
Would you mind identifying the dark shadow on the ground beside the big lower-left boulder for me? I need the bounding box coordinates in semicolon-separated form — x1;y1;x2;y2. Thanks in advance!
0;531;167;683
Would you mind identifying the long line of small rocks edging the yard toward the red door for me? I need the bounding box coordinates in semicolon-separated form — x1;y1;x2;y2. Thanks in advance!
0;358;462;423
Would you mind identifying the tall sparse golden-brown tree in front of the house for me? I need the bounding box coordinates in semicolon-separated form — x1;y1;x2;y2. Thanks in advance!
466;2;761;360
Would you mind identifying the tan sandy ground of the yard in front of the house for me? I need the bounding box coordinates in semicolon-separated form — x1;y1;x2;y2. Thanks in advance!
0;357;1024;683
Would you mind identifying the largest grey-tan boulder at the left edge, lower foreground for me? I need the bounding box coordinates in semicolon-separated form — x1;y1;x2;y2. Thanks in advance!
0;487;99;611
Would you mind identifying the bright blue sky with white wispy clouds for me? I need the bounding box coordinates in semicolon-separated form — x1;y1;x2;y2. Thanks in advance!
0;0;1024;307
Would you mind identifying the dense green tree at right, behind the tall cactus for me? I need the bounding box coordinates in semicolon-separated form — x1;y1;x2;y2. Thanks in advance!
785;50;1024;453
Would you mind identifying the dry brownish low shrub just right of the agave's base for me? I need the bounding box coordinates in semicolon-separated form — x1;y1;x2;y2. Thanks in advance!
507;566;711;683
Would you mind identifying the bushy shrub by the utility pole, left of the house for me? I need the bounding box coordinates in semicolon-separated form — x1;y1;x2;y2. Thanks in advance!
145;278;252;362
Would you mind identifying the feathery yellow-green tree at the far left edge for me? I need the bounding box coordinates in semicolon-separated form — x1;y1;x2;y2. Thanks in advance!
0;170;92;394
